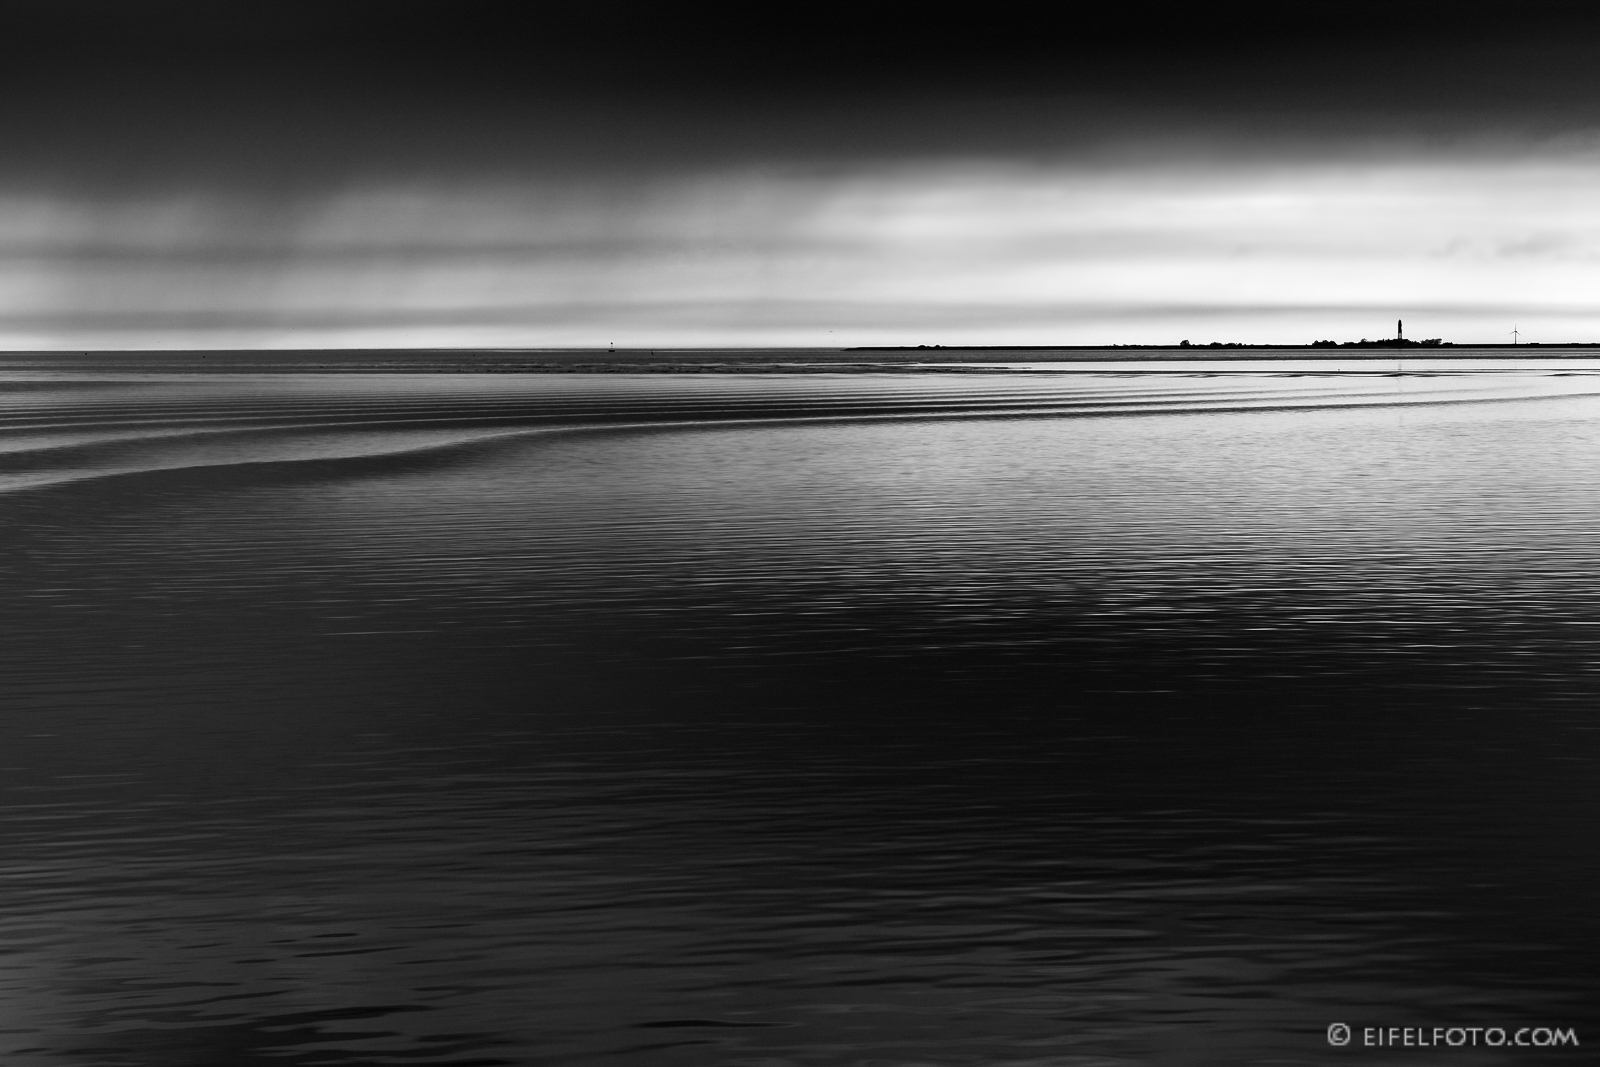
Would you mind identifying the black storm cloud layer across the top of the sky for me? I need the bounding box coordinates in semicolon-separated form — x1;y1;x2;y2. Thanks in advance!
9;0;1600;190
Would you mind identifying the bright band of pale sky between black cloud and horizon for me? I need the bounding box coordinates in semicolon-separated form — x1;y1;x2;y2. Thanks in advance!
0;152;1600;350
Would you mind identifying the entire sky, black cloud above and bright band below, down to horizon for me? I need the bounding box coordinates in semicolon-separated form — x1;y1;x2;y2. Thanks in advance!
0;0;1600;350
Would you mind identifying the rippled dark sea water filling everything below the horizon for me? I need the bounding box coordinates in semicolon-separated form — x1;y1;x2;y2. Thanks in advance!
0;357;1600;1067
